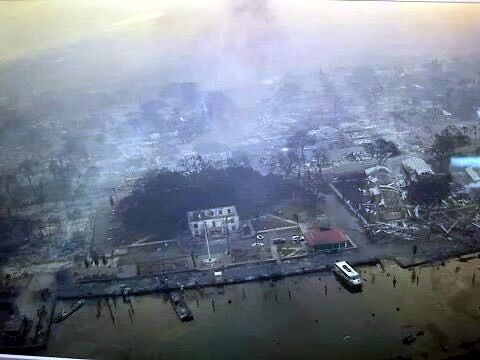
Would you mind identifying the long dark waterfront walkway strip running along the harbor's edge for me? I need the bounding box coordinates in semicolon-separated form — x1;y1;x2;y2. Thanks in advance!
57;242;479;299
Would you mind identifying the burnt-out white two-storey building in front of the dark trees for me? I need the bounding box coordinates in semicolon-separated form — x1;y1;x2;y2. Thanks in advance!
187;205;240;237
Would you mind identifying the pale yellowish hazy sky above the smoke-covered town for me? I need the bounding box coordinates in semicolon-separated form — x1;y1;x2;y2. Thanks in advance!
0;0;480;93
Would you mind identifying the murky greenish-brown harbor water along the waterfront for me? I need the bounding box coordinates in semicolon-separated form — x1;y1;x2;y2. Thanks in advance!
45;259;480;359
